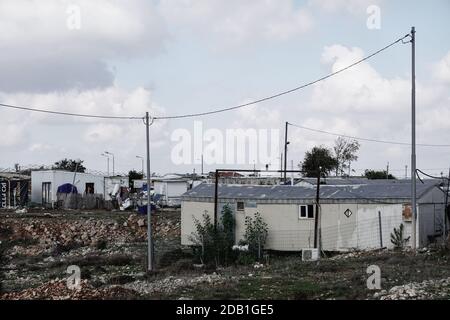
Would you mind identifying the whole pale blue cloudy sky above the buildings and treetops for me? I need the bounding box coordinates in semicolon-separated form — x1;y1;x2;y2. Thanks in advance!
0;0;450;177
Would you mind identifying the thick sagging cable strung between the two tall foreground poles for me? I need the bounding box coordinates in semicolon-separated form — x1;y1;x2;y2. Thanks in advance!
154;34;410;120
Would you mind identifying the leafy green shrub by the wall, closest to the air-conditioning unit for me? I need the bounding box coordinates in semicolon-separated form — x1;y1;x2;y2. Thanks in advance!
245;212;269;261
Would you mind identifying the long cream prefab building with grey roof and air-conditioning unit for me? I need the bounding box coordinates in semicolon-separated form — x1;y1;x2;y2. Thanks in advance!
181;180;448;251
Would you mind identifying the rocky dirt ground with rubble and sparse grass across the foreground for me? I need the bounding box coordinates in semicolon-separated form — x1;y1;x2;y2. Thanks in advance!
0;210;450;299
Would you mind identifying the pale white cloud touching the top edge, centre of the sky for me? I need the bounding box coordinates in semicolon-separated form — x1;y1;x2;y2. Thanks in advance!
159;0;313;47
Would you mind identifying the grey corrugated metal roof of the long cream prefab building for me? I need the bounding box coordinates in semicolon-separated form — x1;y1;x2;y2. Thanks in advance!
182;180;438;200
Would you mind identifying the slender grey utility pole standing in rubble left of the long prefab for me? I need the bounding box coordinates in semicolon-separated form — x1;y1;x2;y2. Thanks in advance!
145;112;154;271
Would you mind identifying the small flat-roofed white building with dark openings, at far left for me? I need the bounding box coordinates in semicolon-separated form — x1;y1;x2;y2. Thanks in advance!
31;170;105;206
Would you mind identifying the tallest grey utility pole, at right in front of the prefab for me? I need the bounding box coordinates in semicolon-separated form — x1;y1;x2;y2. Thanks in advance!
411;27;417;250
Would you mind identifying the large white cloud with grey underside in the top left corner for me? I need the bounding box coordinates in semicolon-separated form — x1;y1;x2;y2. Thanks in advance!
0;0;167;92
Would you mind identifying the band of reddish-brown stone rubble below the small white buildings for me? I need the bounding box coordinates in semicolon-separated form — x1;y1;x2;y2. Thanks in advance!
2;214;180;256
